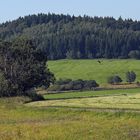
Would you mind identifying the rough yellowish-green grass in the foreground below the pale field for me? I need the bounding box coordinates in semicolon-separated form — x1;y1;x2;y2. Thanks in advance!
0;98;140;140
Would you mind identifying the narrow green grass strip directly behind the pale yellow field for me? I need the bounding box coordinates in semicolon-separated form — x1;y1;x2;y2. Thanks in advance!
44;88;140;100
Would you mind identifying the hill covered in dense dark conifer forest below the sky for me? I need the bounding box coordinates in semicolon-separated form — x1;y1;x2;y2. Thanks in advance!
0;14;140;60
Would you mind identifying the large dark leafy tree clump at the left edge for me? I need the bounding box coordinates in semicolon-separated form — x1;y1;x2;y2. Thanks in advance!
0;38;53;96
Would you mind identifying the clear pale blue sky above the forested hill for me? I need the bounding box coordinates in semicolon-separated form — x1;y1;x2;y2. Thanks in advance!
0;0;140;23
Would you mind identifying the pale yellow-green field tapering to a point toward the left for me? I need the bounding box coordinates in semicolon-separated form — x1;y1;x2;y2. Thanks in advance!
29;93;140;111
